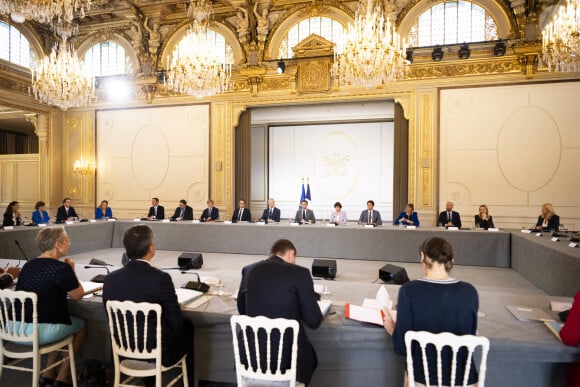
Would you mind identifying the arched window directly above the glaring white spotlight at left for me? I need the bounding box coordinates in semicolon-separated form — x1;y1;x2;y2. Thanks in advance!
84;41;132;77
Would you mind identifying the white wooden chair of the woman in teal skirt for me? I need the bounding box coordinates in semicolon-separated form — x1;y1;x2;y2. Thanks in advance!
0;289;77;387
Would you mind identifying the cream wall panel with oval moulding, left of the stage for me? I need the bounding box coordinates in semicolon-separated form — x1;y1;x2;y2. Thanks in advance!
97;105;209;217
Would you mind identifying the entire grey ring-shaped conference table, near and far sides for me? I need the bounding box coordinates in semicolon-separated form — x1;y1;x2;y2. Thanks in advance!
0;221;580;386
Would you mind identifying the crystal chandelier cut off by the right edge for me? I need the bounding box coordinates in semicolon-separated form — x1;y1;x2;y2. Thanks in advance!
542;0;580;72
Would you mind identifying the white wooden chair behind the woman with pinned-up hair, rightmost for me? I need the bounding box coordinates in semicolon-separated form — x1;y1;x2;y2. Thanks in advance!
405;331;489;387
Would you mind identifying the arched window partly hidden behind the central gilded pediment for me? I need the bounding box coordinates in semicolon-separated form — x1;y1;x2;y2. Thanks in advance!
278;17;344;58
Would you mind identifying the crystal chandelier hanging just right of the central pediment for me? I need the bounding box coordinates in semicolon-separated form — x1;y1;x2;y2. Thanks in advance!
333;0;407;89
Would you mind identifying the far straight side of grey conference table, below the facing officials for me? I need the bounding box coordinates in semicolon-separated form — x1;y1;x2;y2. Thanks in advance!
0;221;511;267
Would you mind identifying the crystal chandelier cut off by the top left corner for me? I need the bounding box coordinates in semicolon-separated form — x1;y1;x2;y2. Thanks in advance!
0;0;92;24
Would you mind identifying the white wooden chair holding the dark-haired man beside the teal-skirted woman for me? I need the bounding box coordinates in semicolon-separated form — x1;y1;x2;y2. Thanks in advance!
107;300;189;387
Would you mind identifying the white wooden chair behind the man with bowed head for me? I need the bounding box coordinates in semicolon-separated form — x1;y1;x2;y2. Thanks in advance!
230;316;304;387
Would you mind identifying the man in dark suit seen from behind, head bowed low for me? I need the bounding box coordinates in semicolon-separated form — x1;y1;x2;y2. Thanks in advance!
237;239;322;385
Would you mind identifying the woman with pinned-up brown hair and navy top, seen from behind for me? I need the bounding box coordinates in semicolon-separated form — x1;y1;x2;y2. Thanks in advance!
384;237;479;386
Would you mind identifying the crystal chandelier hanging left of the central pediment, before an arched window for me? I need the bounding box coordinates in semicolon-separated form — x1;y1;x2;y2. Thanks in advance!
167;0;233;99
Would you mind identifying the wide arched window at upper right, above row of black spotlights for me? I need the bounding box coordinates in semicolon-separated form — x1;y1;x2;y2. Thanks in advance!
407;1;498;47
